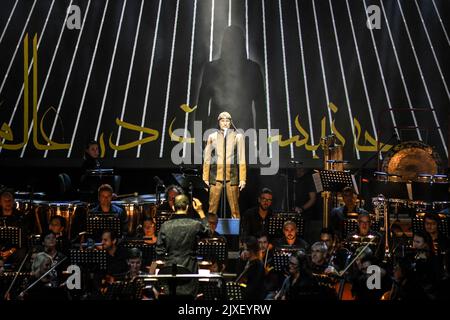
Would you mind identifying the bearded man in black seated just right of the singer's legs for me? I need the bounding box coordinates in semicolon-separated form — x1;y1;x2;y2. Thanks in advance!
239;188;273;239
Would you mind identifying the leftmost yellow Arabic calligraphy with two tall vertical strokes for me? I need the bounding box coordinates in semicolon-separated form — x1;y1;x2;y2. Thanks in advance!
0;34;70;150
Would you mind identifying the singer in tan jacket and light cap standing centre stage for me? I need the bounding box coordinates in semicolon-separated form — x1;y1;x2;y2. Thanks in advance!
203;112;246;218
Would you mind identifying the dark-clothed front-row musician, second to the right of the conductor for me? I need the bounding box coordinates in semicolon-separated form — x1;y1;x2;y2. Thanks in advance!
275;250;320;300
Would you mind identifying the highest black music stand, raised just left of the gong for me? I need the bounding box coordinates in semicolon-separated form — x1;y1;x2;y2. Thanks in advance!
313;170;359;194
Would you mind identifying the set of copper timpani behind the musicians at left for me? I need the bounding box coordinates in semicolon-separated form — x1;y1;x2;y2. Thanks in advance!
15;192;164;239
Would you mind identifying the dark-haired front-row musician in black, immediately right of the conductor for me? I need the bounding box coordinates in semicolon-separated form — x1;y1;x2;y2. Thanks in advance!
236;237;266;300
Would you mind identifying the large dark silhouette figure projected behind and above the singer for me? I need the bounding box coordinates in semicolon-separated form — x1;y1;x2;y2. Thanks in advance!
196;26;267;130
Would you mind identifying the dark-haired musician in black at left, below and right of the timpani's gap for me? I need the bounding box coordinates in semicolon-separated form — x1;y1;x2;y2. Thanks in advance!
102;230;128;279
